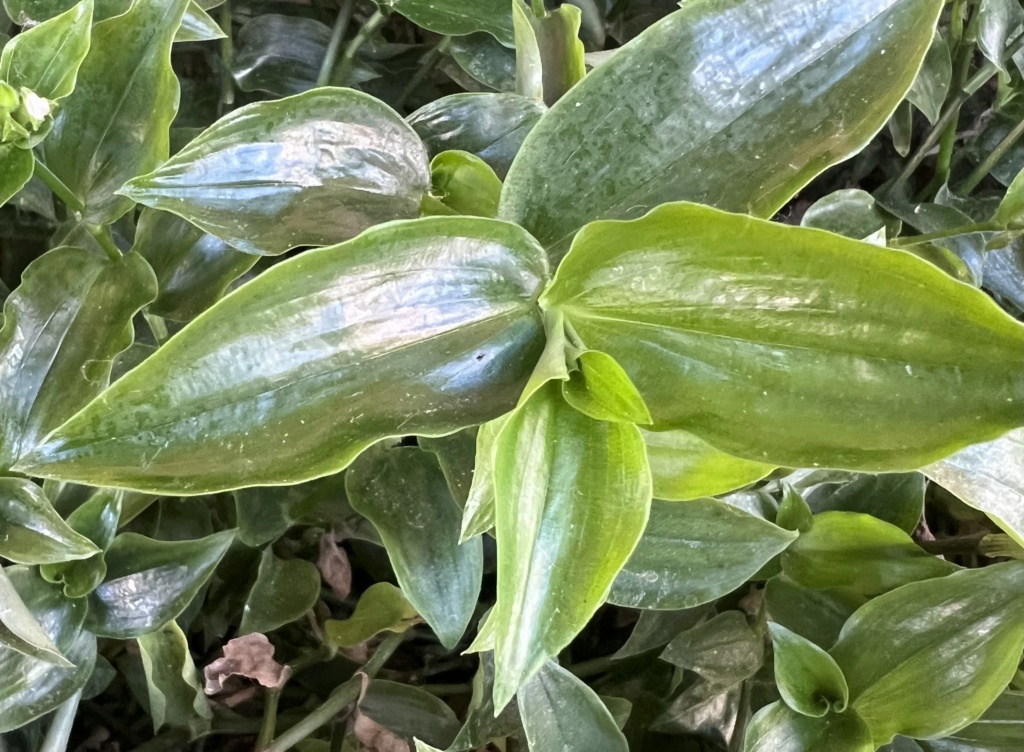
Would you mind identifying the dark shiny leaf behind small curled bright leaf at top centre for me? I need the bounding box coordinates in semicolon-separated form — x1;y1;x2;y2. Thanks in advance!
409;93;545;179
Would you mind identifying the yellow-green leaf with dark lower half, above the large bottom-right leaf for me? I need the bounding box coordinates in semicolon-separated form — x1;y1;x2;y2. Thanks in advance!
782;512;957;595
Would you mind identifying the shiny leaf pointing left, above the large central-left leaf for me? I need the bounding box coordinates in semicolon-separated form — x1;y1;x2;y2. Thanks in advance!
121;87;430;255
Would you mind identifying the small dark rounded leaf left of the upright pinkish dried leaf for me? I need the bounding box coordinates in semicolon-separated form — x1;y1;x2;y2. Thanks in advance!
239;546;321;635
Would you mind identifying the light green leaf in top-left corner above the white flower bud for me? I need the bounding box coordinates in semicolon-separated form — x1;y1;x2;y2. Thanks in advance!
0;0;92;100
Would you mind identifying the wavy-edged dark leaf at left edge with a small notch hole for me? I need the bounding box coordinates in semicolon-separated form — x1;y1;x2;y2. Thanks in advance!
0;248;157;468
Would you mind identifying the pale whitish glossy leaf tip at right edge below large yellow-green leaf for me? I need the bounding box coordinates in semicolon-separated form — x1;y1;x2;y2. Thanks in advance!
923;429;1024;546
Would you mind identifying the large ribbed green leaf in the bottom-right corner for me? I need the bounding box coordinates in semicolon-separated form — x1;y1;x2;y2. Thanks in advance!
829;561;1024;745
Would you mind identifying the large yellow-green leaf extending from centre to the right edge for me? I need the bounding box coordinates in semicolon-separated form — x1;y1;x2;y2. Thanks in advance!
541;204;1024;471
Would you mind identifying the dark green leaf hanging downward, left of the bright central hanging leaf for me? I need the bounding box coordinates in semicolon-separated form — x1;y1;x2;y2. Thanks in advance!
345;446;483;650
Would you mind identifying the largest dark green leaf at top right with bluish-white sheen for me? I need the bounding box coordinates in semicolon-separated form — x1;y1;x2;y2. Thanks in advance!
500;0;943;258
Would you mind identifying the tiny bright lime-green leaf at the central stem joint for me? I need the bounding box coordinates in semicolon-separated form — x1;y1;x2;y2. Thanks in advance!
562;350;651;423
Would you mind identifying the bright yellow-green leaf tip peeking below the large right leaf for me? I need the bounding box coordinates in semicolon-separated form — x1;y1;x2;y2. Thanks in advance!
640;430;775;501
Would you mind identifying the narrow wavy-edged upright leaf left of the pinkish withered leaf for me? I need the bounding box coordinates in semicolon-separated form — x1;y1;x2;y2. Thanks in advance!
138;621;213;734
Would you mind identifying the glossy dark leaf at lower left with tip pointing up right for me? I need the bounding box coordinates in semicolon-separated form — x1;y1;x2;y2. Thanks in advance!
88;530;234;639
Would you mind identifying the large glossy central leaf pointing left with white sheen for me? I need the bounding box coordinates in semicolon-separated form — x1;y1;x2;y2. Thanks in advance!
12;217;547;495
